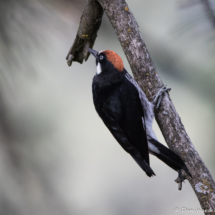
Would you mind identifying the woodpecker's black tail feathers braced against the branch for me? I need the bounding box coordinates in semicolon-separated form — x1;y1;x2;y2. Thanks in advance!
149;138;192;177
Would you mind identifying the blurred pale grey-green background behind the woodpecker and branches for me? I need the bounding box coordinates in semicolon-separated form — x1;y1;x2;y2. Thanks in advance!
0;0;215;215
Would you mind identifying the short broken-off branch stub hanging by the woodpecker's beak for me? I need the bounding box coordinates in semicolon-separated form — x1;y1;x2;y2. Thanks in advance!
66;0;103;66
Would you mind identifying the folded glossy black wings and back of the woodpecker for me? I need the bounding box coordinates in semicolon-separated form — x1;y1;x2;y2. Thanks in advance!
93;74;154;175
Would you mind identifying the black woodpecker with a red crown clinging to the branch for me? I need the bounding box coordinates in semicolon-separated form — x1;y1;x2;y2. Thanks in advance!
88;48;192;188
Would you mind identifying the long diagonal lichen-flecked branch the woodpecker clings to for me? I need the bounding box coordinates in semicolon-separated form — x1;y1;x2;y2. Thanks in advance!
66;0;215;214
